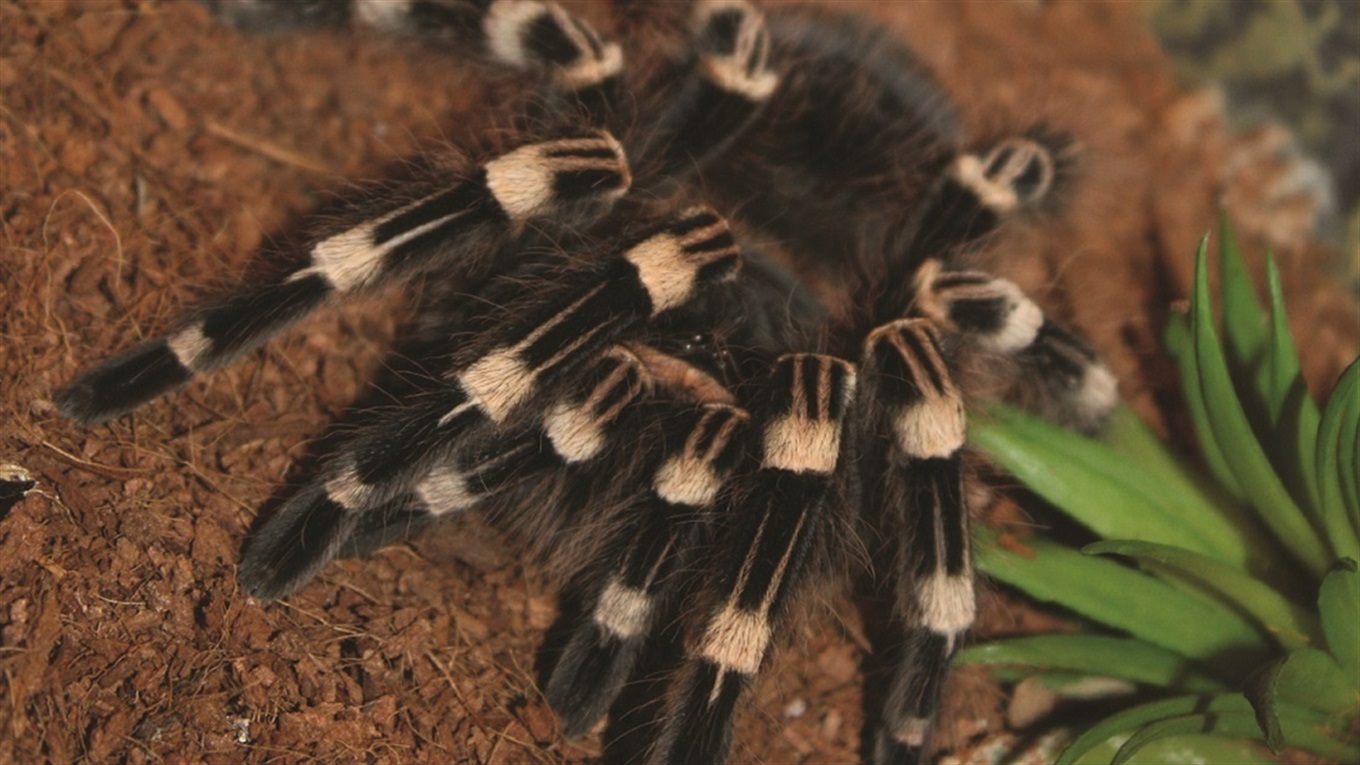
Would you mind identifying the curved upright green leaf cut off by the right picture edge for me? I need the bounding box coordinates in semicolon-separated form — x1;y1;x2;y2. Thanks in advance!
1316;359;1360;547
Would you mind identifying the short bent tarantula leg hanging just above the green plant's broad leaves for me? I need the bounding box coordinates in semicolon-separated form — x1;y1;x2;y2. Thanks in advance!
914;259;1118;432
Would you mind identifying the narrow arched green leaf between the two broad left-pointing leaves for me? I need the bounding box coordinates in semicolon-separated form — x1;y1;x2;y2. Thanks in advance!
1081;540;1322;649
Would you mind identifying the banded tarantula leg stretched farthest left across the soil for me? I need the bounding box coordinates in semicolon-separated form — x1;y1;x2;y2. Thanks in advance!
56;132;630;425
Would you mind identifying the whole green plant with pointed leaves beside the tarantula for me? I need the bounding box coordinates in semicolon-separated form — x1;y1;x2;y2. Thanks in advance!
959;221;1360;764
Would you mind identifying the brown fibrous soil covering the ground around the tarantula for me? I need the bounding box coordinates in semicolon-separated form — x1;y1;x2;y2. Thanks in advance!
0;0;1360;762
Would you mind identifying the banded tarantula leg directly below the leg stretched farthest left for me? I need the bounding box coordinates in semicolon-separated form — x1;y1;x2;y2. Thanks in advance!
242;207;737;598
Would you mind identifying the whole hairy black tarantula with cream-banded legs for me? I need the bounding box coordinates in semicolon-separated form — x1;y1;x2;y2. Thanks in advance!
57;0;1115;762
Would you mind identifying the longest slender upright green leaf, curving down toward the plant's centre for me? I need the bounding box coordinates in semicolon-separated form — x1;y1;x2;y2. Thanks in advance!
1190;238;1331;579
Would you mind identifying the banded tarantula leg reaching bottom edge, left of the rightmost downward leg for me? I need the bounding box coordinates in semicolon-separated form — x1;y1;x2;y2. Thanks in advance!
647;354;855;764
